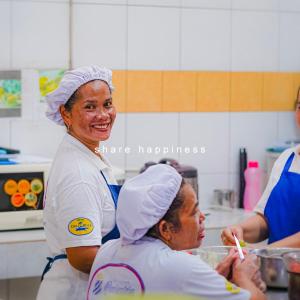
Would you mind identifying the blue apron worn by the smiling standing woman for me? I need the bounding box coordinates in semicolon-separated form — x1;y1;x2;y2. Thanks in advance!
41;171;122;281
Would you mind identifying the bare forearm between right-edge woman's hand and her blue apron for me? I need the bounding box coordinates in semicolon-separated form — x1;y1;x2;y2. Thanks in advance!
240;214;268;243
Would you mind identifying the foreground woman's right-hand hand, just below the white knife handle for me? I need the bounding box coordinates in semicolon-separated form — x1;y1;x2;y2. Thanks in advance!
232;254;259;286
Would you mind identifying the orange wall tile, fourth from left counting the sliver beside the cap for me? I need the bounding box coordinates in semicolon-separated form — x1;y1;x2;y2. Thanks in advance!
197;72;230;111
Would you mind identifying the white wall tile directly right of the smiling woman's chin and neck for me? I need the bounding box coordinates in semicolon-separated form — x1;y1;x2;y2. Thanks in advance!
100;113;126;169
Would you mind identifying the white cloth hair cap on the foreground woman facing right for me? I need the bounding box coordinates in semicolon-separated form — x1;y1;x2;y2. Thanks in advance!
117;164;182;244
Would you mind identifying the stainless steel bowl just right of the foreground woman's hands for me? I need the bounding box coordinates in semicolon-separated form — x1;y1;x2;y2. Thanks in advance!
251;248;291;288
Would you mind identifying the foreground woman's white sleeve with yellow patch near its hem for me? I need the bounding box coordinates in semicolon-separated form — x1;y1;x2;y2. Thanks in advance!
182;260;250;300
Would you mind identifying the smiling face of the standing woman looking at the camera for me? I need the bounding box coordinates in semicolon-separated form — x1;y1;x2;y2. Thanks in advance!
60;80;116;152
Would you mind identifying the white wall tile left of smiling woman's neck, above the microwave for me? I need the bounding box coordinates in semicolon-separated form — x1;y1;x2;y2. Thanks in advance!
11;120;65;158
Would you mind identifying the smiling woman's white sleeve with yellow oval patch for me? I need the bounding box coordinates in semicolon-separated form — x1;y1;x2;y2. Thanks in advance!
56;183;104;249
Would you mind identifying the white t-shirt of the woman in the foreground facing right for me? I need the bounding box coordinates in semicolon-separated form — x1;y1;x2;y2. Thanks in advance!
87;237;250;300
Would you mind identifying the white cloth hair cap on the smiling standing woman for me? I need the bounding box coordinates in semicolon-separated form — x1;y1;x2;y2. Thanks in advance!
46;65;113;125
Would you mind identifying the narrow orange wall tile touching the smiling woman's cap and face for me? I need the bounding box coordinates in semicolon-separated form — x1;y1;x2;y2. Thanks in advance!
113;70;127;112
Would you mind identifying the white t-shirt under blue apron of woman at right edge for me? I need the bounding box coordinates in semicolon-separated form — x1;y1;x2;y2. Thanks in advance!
254;145;300;215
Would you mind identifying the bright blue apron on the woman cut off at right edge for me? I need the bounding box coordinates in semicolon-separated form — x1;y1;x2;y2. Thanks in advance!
264;152;300;244
